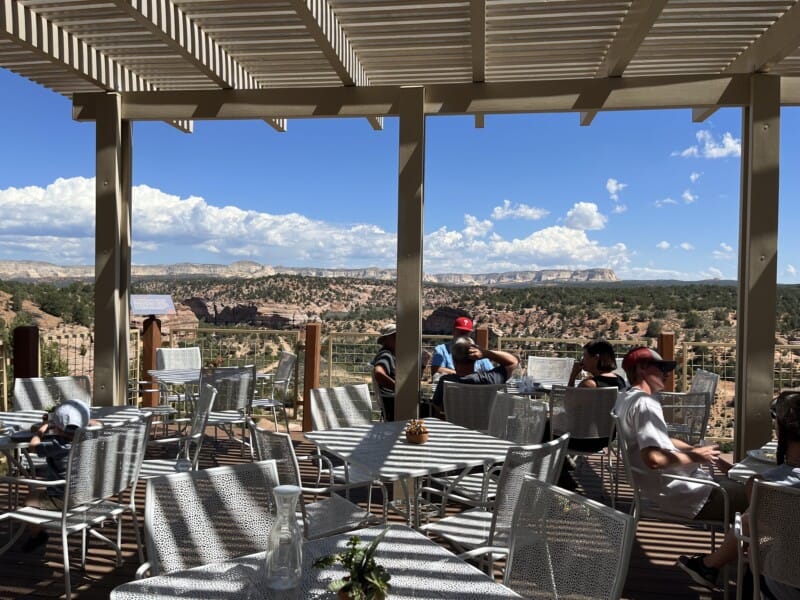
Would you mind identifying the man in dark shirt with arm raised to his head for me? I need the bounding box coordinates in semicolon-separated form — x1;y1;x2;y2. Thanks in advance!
432;337;519;416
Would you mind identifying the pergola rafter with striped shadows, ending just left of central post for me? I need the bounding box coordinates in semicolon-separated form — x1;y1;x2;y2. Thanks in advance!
290;0;383;130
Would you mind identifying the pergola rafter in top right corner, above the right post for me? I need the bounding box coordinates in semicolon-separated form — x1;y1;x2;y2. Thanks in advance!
692;4;800;123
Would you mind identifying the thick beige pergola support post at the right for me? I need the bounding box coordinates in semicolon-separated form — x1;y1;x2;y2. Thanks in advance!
734;74;781;460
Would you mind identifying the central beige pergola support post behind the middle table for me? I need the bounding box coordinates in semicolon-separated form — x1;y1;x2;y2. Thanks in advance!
394;87;425;421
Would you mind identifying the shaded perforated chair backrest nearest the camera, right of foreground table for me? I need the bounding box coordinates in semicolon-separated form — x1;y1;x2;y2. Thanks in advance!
504;476;636;600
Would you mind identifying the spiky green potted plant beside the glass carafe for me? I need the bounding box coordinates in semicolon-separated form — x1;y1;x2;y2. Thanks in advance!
314;529;391;600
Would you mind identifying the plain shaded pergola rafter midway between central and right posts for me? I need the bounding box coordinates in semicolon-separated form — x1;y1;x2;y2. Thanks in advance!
580;0;667;126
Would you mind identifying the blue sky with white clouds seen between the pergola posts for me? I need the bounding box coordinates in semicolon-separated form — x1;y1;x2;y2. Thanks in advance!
0;69;800;283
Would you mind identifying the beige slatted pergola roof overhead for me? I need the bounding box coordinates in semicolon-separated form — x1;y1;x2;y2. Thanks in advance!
0;0;800;123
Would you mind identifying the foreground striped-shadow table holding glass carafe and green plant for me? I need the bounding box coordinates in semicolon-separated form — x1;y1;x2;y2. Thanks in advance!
111;525;521;600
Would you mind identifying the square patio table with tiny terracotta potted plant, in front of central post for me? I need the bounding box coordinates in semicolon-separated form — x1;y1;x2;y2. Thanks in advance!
304;418;514;527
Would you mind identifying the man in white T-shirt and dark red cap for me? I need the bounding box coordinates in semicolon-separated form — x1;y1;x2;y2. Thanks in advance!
614;346;747;520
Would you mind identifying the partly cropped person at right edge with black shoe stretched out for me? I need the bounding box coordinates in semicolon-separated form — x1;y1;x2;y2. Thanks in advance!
676;391;800;600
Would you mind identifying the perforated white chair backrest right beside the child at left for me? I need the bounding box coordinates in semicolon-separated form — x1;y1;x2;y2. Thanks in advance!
64;413;152;510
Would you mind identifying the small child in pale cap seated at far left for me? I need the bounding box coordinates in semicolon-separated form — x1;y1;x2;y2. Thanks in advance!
21;399;97;552
